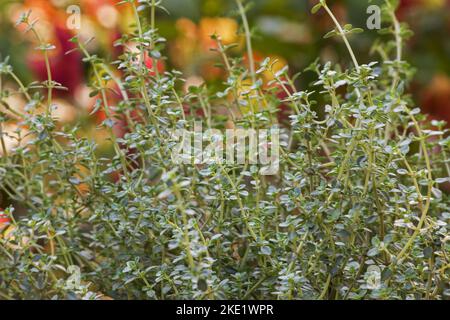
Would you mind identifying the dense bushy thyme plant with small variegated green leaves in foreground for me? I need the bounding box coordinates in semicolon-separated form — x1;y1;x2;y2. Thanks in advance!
0;0;450;299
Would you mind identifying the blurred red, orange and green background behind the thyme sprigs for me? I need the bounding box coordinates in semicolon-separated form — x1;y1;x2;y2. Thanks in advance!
0;0;450;141
